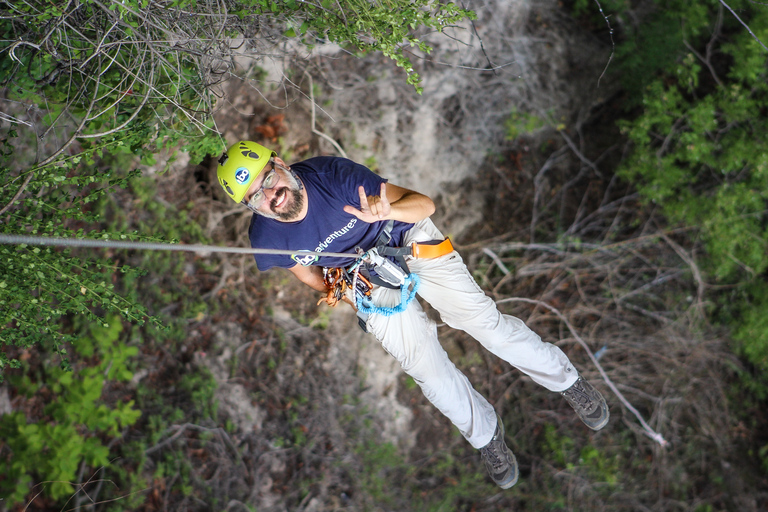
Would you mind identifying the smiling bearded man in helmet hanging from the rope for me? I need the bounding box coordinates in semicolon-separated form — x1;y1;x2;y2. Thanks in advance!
218;141;609;489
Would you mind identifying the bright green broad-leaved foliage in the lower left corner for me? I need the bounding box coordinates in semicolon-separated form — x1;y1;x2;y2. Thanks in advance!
0;315;141;505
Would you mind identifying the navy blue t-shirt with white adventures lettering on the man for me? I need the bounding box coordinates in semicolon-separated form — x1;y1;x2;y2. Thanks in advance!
249;156;413;271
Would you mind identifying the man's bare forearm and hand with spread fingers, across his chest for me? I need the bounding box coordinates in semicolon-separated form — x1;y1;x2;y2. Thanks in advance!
344;183;435;223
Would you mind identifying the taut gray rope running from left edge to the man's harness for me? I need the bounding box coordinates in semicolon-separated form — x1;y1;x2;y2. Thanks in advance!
0;234;359;258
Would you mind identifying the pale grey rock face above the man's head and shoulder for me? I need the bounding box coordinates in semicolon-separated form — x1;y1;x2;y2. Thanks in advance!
318;0;611;195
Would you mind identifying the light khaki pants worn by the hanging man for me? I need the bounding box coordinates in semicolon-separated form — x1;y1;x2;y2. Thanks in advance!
367;219;578;448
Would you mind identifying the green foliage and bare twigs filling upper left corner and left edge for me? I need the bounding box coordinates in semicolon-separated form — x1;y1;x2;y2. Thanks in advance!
0;0;472;379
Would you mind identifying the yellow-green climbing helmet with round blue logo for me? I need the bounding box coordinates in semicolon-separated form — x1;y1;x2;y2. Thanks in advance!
216;140;277;203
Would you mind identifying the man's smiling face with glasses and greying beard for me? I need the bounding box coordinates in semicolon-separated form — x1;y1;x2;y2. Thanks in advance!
243;161;304;222
